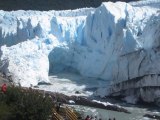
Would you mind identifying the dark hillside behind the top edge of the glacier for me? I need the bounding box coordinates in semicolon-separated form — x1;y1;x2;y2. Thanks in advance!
0;0;136;11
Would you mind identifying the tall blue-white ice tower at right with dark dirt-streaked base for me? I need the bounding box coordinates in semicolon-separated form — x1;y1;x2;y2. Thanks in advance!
80;1;160;103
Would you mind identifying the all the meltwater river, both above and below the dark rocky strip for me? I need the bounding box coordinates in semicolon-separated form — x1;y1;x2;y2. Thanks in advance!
39;72;160;120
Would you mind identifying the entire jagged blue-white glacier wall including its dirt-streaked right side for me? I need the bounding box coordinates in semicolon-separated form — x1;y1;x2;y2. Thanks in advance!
0;1;160;102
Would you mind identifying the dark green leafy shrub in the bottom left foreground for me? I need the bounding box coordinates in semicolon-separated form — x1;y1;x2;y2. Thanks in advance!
1;87;53;120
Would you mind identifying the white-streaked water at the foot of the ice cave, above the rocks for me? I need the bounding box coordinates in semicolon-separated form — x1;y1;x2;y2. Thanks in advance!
39;72;109;96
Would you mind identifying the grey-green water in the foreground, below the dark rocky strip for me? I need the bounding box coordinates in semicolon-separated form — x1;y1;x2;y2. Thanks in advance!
72;106;160;120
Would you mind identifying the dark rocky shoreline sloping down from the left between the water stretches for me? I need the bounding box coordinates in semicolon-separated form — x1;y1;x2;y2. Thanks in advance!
0;73;130;113
